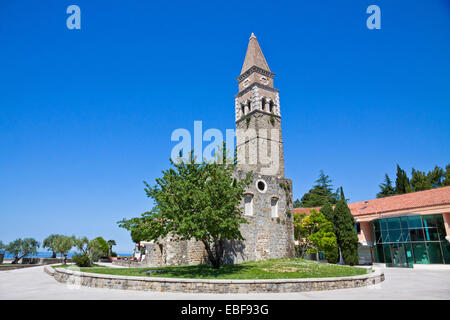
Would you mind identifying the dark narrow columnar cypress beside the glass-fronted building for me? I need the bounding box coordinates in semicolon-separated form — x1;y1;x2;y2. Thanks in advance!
334;194;358;265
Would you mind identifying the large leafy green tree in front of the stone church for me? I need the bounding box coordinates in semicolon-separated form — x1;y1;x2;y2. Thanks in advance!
119;147;251;268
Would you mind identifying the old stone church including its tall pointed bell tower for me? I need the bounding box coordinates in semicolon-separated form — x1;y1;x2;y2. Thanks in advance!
140;34;294;266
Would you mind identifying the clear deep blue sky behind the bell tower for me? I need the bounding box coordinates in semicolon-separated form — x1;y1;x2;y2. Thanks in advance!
0;0;450;252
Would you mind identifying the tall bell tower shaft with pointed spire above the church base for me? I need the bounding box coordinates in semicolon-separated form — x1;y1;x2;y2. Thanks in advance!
235;33;284;177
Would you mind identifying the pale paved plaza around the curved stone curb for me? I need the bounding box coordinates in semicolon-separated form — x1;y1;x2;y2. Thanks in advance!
0;265;450;300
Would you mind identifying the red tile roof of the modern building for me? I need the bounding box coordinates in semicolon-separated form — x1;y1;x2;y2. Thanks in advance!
294;186;450;216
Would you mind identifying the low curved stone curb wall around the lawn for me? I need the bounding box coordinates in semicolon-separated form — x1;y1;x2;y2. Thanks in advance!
44;266;384;293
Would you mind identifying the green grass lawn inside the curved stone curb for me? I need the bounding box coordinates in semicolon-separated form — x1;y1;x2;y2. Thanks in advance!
56;258;367;279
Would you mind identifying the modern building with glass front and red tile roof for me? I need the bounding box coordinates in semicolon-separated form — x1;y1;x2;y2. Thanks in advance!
349;187;450;267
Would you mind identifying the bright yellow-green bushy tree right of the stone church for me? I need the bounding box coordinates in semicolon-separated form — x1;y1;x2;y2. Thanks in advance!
297;210;337;260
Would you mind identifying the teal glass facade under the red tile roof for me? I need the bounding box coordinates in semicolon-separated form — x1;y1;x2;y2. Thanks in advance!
373;214;450;267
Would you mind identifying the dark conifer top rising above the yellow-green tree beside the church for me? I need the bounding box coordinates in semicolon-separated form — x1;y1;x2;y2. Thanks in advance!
301;170;338;208
